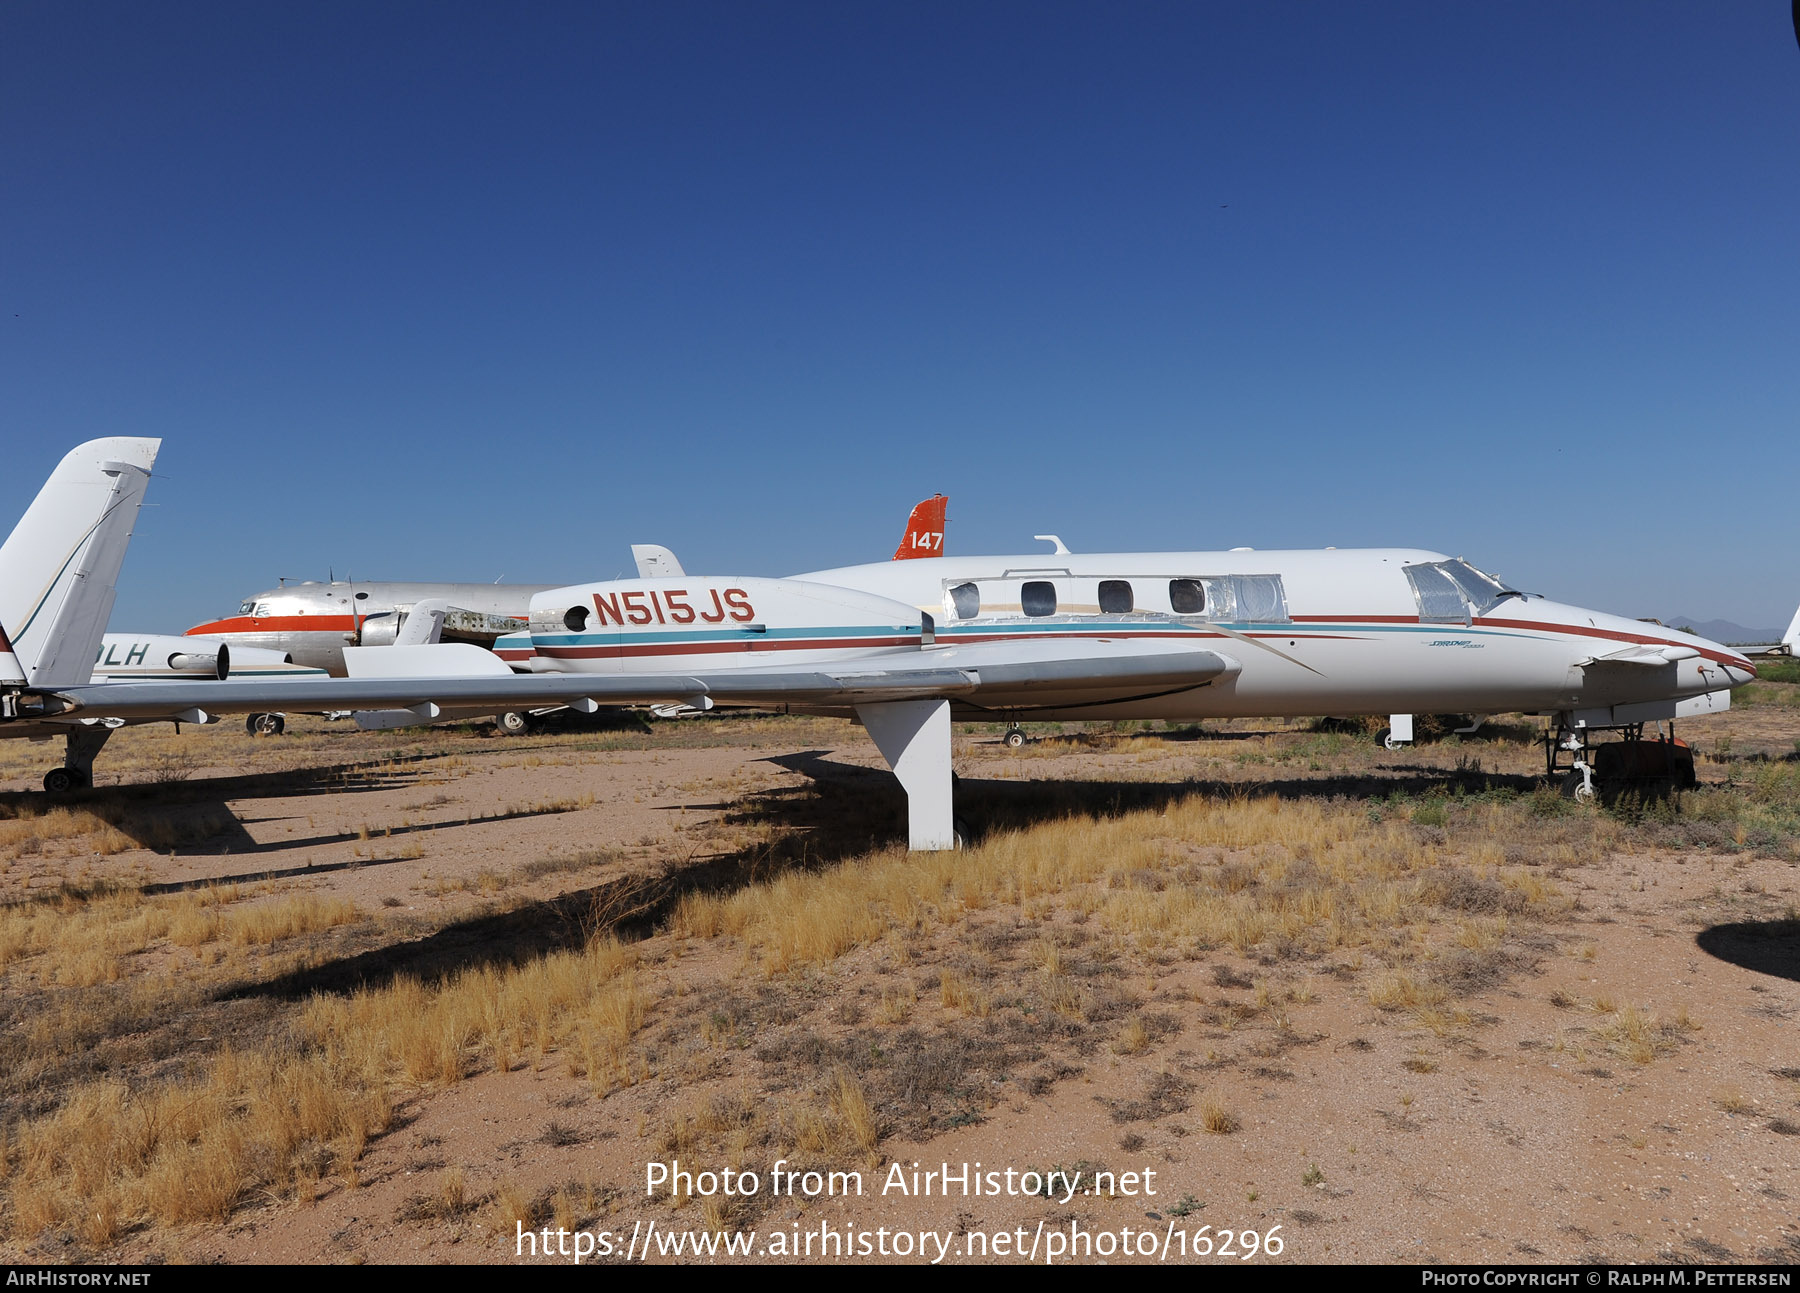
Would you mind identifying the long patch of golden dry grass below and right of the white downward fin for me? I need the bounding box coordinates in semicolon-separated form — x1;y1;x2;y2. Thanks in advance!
673;796;1555;979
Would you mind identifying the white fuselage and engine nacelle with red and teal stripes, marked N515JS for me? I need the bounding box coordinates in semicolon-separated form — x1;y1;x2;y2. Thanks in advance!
522;549;1755;728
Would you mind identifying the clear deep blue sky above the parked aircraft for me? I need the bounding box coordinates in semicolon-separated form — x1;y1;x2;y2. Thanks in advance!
0;0;1800;630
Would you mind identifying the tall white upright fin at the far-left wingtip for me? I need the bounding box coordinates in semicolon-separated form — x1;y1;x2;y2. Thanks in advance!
0;436;162;686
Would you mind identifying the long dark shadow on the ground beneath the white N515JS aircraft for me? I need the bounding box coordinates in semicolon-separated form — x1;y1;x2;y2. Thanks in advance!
227;749;1535;999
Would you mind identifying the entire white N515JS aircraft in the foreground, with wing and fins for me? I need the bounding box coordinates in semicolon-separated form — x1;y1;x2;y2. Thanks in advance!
0;439;1755;850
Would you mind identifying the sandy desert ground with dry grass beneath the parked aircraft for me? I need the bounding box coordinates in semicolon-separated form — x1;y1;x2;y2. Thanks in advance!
0;672;1800;1262
